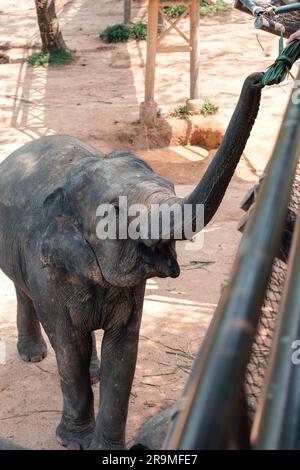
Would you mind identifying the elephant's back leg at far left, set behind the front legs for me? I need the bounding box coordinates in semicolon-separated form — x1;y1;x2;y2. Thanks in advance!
15;285;47;362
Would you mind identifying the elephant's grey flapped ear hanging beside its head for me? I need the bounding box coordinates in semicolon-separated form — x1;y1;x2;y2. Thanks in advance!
41;188;102;283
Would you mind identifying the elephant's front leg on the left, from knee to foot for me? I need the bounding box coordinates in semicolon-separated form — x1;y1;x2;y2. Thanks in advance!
55;324;95;449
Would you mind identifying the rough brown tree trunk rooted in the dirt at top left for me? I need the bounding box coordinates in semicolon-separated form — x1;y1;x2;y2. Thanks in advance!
35;0;67;54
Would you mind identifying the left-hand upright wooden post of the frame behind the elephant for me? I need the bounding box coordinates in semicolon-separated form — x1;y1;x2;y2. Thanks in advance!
140;0;159;125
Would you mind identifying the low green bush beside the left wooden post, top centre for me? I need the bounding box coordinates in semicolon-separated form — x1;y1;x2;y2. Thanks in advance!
100;21;147;43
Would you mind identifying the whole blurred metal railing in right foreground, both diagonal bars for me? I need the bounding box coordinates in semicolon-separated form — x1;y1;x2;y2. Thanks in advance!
164;72;300;450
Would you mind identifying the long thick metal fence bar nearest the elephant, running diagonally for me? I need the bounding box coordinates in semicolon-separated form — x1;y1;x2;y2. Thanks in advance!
164;72;300;450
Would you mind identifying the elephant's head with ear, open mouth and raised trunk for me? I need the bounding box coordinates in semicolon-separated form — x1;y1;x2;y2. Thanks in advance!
42;74;262;287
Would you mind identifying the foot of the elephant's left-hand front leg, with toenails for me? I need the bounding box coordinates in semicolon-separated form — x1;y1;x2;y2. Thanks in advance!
56;423;95;450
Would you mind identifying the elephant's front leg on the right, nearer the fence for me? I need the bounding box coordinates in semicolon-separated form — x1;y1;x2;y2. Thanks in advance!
90;312;141;450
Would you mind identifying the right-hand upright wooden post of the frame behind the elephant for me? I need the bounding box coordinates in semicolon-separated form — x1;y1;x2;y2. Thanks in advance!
187;0;200;111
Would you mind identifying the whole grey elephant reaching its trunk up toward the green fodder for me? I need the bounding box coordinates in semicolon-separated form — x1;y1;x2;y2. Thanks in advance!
0;73;263;450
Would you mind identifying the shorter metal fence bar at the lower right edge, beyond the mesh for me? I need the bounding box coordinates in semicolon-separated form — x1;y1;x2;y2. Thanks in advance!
252;212;300;449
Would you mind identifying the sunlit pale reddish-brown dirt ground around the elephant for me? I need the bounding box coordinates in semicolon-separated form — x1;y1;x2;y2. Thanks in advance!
0;0;291;449
